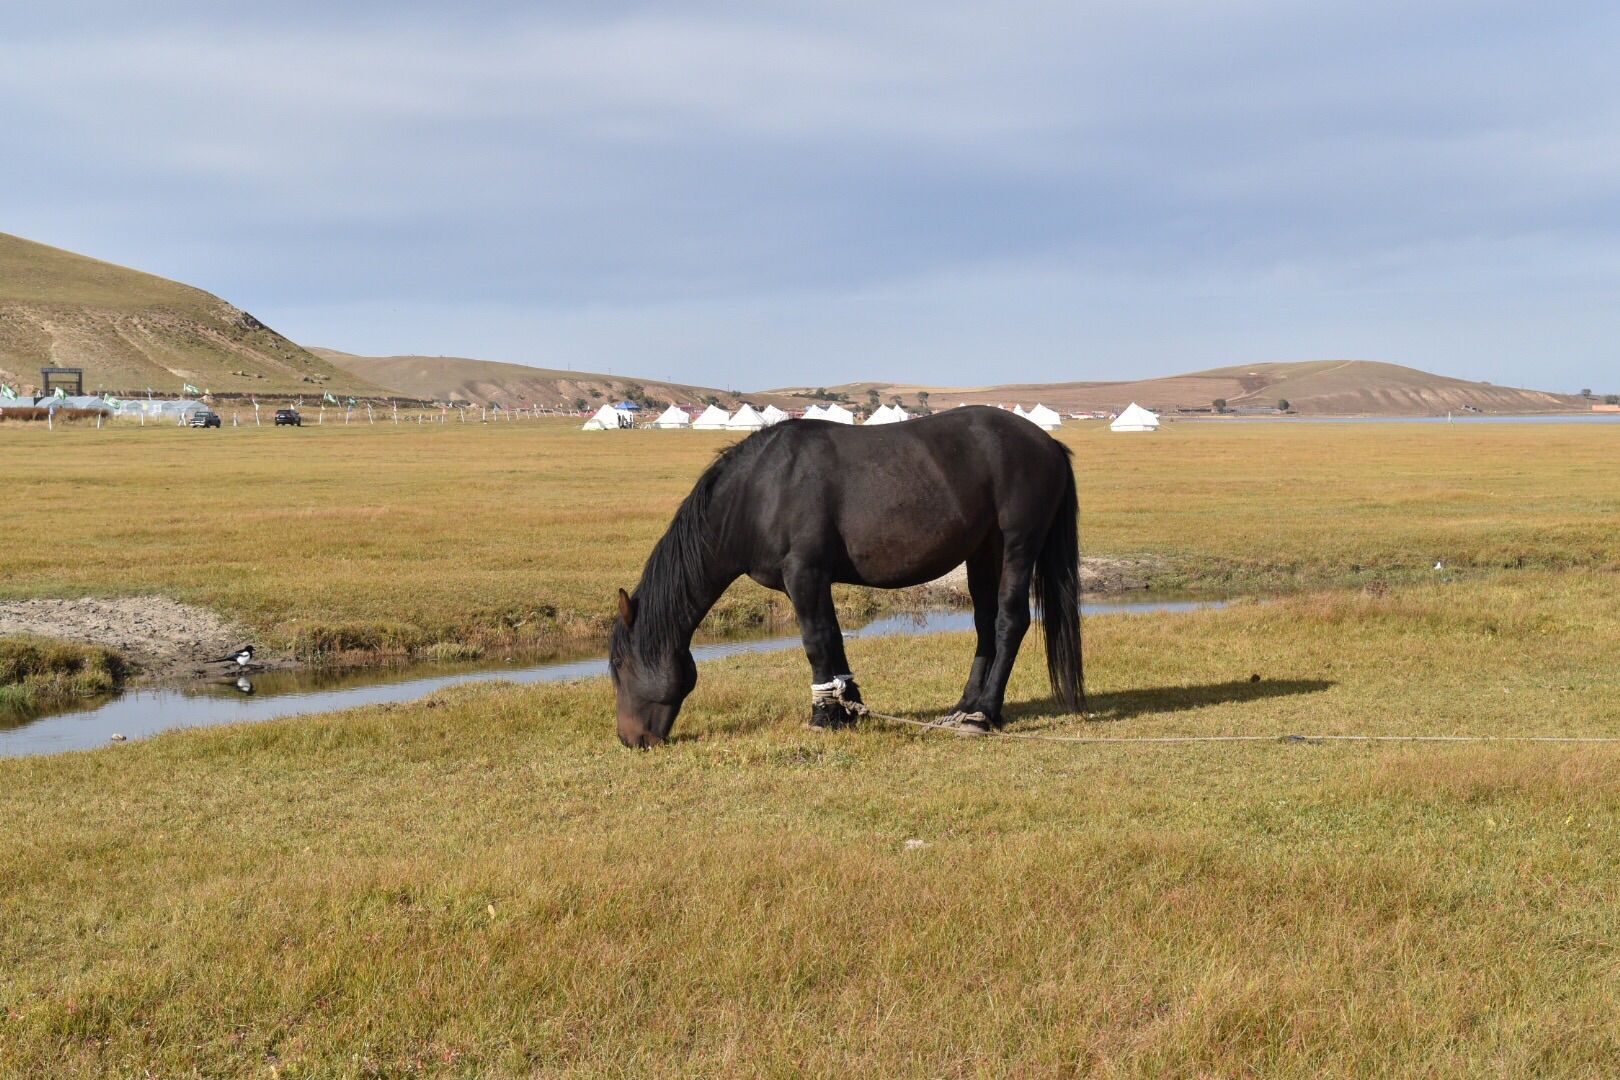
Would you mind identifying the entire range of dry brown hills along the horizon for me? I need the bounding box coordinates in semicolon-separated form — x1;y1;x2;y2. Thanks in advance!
0;233;1591;416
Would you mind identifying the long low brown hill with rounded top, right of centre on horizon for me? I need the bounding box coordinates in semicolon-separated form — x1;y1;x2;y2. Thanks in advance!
790;359;1591;416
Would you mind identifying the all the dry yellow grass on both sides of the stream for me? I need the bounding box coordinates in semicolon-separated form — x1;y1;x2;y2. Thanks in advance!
0;423;1620;1077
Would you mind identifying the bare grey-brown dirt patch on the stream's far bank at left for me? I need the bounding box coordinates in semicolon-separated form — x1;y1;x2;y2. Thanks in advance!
0;596;251;678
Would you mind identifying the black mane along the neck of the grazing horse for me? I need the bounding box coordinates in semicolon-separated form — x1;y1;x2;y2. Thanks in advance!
612;426;781;657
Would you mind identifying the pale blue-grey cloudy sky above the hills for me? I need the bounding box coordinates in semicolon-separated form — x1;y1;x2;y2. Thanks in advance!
0;0;1620;390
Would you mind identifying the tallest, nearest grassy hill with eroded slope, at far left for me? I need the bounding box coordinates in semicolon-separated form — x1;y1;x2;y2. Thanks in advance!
0;233;376;395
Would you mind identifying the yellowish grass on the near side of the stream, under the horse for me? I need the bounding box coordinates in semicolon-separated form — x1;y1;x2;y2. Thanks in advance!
0;573;1620;1077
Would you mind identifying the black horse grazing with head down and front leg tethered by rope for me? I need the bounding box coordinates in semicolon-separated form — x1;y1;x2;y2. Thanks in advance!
609;406;1085;748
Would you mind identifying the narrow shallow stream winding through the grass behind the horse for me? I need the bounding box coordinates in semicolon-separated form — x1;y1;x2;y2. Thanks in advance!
0;601;1225;758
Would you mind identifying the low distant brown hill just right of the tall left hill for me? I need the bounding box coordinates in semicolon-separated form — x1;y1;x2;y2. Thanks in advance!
309;348;808;408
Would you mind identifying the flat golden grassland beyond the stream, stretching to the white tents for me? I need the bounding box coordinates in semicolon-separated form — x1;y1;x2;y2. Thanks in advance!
0;415;1620;663
